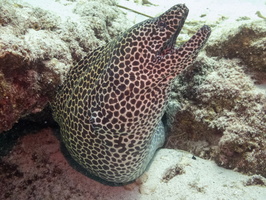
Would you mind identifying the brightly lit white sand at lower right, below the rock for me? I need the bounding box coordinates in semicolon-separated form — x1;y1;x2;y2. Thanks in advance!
125;149;266;200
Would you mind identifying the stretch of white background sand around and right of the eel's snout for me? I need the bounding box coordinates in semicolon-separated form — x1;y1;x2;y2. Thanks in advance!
118;0;266;23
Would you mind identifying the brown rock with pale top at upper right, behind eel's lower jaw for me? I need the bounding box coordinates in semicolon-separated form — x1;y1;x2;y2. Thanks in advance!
206;20;266;84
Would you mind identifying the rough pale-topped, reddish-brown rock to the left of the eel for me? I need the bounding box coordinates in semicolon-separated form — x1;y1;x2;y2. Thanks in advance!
0;0;127;132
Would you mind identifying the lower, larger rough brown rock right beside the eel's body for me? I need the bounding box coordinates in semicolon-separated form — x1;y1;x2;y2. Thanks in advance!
167;56;266;176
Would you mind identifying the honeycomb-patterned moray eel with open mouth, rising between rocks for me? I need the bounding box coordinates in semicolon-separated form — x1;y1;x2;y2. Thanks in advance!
51;4;211;184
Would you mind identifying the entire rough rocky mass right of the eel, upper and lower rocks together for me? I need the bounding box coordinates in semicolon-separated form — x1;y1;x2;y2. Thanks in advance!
167;21;266;176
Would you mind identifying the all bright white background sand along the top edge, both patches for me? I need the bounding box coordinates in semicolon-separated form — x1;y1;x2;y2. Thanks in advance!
21;0;266;23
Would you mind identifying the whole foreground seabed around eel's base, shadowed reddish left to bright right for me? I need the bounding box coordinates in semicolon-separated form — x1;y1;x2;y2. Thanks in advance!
0;128;266;200
